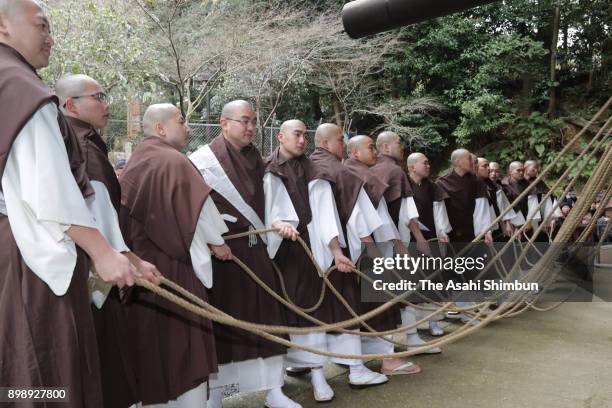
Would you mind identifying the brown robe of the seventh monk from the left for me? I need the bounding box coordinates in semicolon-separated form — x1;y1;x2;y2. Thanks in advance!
344;159;402;331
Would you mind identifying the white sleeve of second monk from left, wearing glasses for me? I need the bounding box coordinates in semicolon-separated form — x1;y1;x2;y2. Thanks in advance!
85;180;130;252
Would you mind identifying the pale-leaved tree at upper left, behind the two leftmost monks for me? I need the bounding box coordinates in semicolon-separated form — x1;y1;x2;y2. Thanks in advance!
42;0;160;115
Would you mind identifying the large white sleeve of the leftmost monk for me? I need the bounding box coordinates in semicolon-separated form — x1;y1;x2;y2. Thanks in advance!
2;103;95;295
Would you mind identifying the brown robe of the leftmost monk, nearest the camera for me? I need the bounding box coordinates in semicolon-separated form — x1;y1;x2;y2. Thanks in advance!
0;44;102;408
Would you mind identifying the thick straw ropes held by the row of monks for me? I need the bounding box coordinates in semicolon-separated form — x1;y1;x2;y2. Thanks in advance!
118;98;612;360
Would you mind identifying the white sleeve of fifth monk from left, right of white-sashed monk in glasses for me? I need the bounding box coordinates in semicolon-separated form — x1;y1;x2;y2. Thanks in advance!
264;173;300;259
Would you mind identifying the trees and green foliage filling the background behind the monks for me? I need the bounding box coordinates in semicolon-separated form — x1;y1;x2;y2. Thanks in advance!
43;0;612;184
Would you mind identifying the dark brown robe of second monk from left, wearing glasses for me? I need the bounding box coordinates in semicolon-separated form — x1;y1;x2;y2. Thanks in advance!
66;116;139;408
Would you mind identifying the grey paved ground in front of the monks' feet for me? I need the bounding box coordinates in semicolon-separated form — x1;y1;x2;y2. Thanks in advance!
224;302;612;408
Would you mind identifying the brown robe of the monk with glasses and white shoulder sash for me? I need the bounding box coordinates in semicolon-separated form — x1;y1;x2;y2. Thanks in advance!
200;135;286;364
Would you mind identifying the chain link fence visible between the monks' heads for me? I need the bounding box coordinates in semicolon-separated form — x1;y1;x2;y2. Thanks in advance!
104;120;315;158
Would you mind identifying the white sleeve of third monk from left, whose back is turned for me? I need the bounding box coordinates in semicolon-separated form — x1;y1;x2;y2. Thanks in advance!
189;197;228;289
